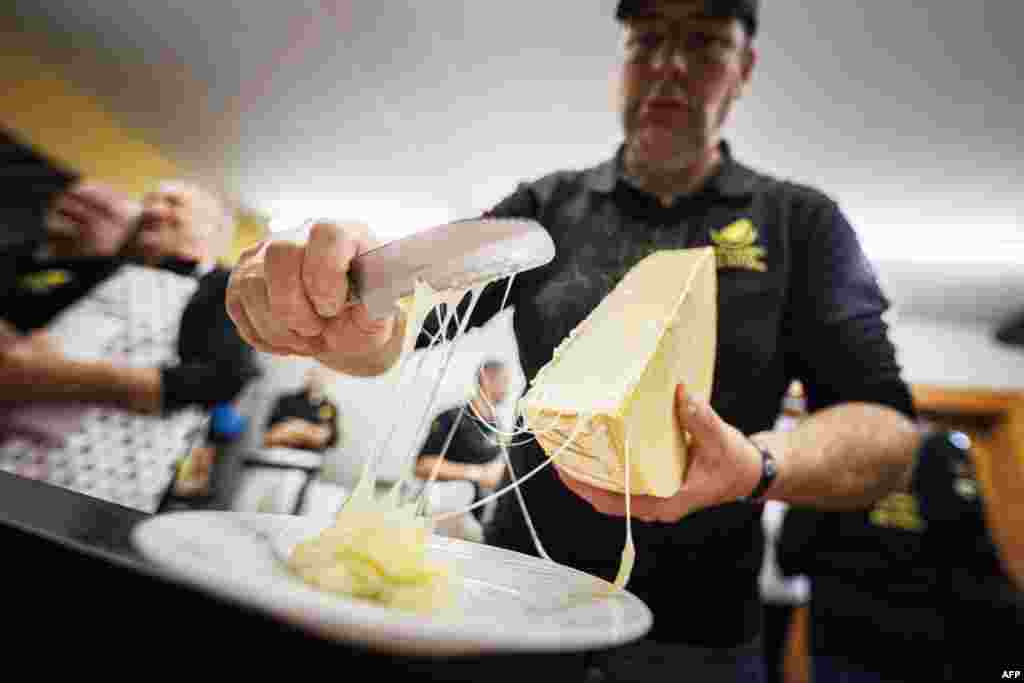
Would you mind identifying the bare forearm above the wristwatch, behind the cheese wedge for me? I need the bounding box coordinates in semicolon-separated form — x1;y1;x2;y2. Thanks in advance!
753;403;921;510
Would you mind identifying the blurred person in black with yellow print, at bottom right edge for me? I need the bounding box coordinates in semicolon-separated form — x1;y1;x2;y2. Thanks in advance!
778;430;1024;683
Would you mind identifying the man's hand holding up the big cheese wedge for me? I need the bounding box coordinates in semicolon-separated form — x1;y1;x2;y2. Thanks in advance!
556;385;762;523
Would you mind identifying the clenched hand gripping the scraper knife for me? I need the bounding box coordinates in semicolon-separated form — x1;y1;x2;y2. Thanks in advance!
226;222;400;374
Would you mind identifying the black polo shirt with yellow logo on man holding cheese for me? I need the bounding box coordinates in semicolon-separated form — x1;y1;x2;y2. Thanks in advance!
428;143;912;646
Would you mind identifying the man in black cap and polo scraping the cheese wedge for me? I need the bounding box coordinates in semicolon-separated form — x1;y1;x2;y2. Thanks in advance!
227;0;919;681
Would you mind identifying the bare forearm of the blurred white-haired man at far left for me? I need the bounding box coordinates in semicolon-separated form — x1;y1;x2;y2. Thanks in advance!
0;358;162;414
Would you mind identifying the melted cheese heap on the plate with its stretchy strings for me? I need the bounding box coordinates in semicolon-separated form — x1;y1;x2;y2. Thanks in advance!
290;264;634;610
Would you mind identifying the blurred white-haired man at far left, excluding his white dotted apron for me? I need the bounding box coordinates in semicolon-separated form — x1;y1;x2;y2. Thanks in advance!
0;179;258;414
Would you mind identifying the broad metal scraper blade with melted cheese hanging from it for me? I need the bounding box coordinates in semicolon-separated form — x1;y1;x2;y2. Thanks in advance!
274;218;555;317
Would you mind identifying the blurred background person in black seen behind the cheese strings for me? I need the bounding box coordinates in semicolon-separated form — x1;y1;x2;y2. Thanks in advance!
416;360;509;517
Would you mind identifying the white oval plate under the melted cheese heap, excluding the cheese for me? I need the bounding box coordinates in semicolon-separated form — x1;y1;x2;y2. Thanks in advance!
132;511;652;654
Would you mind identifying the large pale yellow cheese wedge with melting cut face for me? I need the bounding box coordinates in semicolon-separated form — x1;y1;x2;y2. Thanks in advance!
523;247;718;498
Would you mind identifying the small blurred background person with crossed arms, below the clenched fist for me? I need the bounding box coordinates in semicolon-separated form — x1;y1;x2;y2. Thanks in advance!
263;366;340;452
